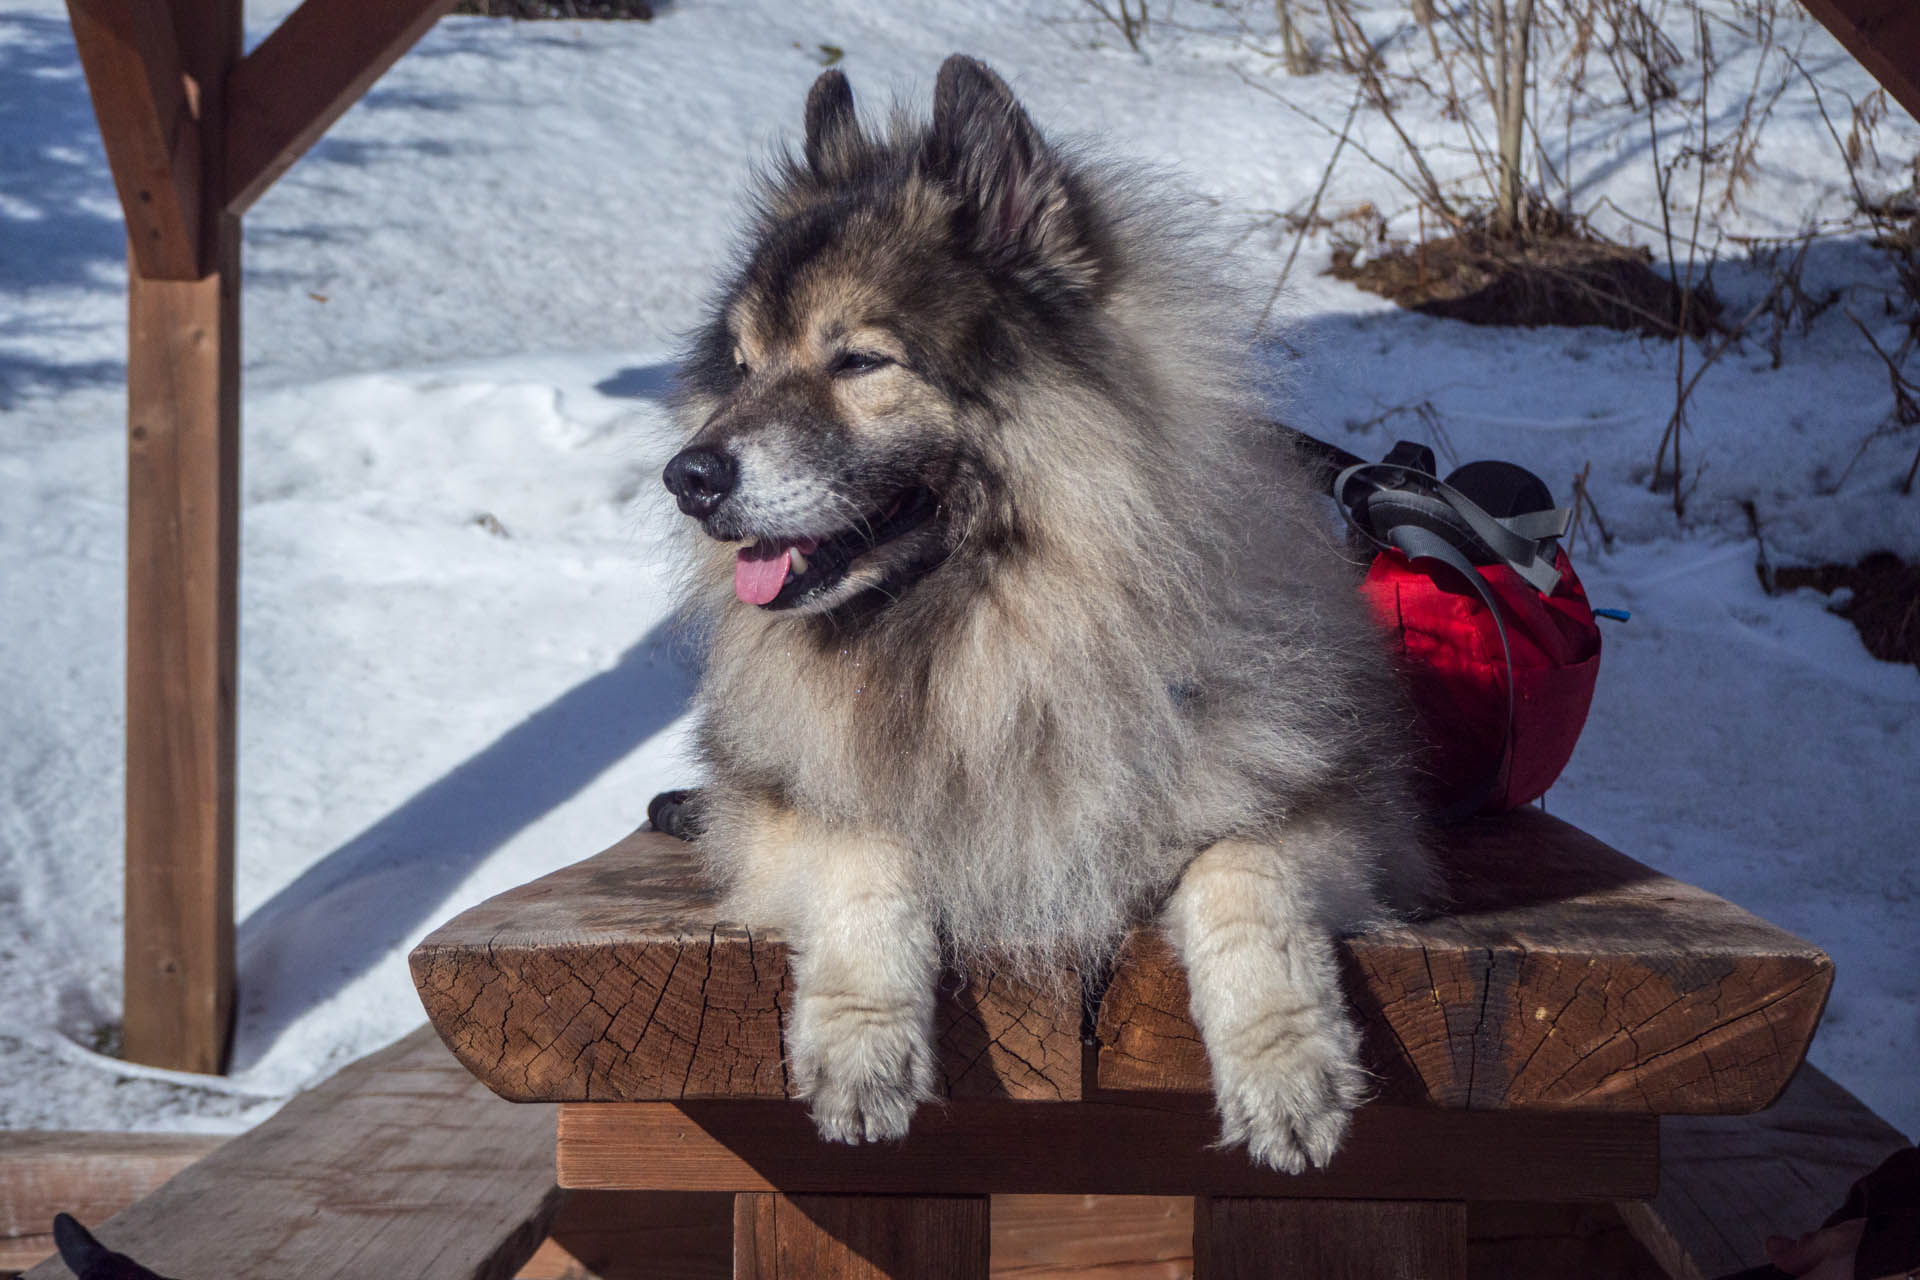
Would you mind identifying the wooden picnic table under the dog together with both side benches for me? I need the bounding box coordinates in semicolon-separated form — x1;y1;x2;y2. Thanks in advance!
7;814;1899;1280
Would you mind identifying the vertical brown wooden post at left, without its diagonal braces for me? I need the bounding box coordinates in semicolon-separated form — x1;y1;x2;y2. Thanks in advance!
125;0;240;1071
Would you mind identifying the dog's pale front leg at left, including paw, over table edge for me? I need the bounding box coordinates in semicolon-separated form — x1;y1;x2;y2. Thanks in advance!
787;831;941;1142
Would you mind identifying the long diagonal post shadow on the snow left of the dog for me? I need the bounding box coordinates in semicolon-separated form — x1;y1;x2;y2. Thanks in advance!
232;620;697;1071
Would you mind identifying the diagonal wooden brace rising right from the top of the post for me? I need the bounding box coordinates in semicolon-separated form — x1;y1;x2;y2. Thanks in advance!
227;0;455;213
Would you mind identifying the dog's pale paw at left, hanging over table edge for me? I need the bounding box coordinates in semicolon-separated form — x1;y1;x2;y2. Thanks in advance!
789;998;933;1144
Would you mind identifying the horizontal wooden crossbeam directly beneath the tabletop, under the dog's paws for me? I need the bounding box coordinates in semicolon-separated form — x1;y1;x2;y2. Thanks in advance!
559;1098;1659;1201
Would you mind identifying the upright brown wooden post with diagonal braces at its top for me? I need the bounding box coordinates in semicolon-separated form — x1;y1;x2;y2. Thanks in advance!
67;0;453;1071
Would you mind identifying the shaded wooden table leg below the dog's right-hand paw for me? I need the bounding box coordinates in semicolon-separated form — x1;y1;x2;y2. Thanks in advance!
1198;1196;1467;1280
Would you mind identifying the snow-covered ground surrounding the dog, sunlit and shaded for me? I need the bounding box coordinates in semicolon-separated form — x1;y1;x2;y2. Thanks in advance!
0;0;1920;1132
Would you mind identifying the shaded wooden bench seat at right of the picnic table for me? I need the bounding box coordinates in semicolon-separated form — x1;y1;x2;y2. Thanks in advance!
1620;1065;1908;1280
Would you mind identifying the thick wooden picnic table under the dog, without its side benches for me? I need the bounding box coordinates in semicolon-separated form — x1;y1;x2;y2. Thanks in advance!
413;810;1832;1280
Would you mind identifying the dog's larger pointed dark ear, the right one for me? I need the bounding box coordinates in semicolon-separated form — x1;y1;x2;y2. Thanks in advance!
922;54;1092;284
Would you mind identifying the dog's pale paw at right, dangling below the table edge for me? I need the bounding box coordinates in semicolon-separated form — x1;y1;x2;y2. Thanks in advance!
1208;1007;1367;1173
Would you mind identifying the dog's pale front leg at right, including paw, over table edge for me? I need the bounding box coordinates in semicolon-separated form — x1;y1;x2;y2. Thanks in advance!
1165;833;1367;1173
